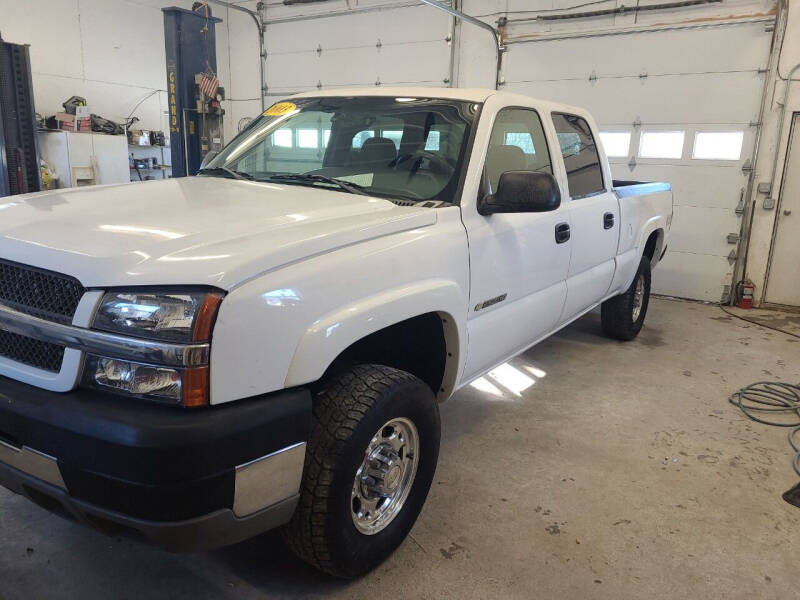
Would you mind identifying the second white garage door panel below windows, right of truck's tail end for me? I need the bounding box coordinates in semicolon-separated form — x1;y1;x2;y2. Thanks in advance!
669;206;740;257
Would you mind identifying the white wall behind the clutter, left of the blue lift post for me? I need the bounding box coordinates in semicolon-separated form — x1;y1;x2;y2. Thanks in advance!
0;0;198;130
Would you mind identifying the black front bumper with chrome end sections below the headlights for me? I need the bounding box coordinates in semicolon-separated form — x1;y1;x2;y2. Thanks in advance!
0;377;311;551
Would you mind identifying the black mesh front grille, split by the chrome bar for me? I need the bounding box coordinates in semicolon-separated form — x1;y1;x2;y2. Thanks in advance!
0;260;85;373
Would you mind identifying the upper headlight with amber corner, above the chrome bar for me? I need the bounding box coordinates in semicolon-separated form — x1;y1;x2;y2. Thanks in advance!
93;291;222;343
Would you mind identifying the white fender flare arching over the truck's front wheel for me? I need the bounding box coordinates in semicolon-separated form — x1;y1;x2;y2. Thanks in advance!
284;279;467;399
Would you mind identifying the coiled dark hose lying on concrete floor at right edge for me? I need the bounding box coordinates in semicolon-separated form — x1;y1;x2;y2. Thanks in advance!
728;381;800;475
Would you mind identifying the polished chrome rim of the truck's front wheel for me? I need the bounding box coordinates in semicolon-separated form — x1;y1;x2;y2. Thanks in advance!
350;417;419;535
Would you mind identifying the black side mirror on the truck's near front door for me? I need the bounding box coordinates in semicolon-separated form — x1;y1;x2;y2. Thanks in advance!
478;171;561;215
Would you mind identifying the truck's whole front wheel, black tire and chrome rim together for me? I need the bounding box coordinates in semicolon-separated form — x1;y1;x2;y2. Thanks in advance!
283;365;440;577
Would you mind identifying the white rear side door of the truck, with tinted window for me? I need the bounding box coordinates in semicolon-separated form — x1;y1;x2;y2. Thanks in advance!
552;113;619;321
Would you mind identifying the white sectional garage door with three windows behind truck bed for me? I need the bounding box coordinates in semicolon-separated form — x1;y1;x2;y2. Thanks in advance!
503;22;771;301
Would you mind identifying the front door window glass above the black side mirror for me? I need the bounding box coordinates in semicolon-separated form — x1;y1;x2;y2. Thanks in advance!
484;108;553;194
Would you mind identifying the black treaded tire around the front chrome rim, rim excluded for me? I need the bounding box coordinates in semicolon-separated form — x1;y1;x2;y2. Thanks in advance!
282;365;440;578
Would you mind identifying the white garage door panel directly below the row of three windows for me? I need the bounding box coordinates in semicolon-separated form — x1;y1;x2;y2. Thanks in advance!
624;164;747;210
